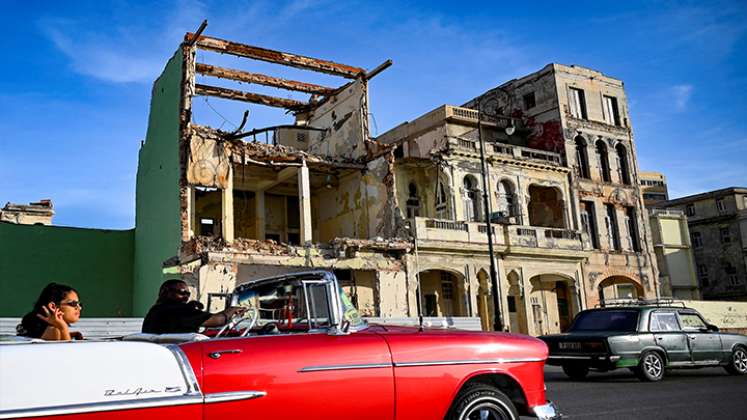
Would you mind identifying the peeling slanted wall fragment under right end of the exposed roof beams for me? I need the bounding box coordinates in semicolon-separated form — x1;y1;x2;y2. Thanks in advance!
301;79;368;160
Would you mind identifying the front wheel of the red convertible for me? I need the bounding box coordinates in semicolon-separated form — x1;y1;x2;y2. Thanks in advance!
446;384;519;420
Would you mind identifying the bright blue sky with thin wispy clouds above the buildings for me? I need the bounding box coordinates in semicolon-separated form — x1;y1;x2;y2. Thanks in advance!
0;0;747;228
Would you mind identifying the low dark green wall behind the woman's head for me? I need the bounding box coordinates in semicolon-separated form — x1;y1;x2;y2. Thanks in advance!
0;223;134;317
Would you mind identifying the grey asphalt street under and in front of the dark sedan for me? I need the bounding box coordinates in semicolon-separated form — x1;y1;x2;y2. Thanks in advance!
524;366;747;420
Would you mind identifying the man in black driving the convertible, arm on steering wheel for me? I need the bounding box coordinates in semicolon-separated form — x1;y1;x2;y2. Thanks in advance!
142;279;244;334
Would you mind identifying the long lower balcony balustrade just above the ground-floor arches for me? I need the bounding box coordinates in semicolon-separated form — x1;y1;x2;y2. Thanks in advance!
414;217;584;251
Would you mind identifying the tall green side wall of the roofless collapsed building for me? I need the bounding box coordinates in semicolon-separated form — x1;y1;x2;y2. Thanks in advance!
132;49;182;316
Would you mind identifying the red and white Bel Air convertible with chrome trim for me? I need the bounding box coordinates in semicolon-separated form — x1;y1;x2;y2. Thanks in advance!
0;271;560;420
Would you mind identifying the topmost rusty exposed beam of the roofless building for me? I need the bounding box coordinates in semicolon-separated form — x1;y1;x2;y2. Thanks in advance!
184;32;366;79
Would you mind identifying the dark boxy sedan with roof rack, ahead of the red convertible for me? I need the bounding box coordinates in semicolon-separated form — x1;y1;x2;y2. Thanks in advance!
539;301;747;382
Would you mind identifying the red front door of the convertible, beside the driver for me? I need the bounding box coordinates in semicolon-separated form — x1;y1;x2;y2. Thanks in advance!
202;282;394;420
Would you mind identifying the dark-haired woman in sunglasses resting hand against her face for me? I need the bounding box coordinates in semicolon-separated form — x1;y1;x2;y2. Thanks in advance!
16;283;83;341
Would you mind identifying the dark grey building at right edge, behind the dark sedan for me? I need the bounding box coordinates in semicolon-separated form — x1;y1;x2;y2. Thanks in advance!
658;187;747;301
